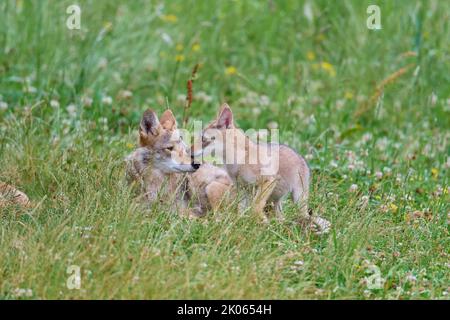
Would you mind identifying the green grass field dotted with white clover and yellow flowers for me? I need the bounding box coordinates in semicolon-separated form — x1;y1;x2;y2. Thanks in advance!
0;0;450;299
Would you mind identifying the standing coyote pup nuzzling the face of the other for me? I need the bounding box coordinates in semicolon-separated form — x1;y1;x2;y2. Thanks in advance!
191;104;330;233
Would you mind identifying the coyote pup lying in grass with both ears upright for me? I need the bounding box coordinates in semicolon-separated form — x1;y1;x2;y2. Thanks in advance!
126;110;233;216
